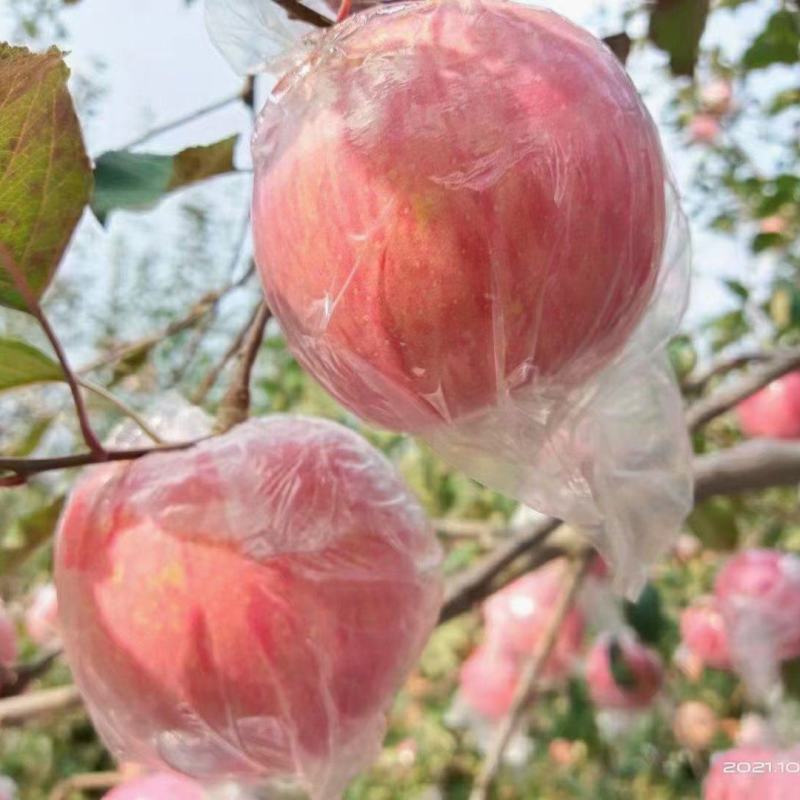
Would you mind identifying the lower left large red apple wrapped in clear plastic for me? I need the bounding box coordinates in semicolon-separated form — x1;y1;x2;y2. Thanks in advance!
56;415;441;797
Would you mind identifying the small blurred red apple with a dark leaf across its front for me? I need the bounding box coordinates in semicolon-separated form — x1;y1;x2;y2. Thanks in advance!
586;633;664;711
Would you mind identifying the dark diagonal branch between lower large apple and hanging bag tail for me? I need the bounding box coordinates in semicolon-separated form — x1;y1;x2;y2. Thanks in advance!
439;519;561;624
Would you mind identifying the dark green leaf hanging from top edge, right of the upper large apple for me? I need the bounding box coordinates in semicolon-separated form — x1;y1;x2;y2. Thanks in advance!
648;0;709;76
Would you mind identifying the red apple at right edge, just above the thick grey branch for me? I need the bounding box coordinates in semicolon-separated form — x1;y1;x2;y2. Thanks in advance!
736;372;800;439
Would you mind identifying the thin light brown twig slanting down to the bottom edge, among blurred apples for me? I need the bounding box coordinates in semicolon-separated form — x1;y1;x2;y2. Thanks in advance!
470;549;592;800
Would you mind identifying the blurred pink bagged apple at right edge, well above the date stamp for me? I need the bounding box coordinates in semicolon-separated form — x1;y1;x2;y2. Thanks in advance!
714;548;800;665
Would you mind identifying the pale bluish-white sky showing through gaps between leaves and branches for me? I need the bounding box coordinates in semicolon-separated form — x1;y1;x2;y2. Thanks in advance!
0;0;780;344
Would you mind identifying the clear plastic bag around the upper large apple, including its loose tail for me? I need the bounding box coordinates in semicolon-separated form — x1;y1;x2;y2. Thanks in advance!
210;0;692;593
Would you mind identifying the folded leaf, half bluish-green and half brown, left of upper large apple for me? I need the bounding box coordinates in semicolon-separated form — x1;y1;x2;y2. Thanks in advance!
92;136;239;223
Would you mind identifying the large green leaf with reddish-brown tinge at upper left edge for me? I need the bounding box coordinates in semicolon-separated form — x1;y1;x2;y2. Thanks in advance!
0;44;92;310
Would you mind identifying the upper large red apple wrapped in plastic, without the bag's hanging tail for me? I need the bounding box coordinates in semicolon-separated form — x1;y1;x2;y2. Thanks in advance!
253;0;666;432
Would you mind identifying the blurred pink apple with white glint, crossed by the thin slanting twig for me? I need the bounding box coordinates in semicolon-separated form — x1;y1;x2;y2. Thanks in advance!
483;559;585;682
